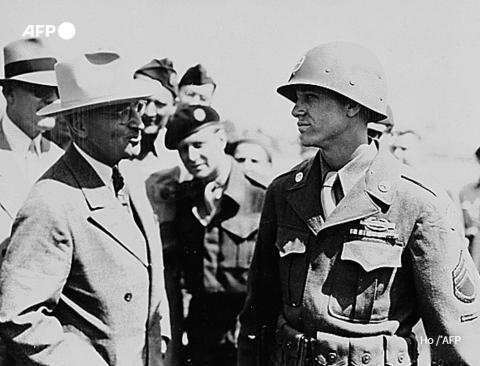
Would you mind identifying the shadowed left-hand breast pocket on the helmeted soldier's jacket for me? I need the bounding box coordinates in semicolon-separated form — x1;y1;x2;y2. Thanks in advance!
275;227;310;307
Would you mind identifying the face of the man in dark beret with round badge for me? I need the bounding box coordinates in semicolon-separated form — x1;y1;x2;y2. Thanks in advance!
177;126;226;181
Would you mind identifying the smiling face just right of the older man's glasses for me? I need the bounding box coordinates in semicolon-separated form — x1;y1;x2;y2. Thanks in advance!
142;81;175;134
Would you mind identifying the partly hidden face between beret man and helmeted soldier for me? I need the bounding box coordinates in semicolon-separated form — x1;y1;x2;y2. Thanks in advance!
233;142;272;174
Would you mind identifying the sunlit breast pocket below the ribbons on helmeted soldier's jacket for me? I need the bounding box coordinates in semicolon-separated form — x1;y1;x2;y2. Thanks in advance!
328;239;403;323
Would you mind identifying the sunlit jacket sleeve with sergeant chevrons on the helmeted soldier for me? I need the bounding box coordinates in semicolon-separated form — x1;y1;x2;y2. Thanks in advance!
409;196;480;365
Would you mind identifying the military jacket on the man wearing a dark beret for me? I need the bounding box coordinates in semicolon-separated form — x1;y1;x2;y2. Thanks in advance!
173;159;265;294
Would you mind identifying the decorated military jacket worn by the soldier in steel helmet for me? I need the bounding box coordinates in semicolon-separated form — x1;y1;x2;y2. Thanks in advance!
239;147;480;366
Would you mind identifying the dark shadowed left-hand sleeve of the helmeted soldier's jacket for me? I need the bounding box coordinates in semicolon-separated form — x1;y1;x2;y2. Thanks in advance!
238;182;282;366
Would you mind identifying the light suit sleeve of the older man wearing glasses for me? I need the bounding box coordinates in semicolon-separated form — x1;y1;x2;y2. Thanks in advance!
0;184;107;366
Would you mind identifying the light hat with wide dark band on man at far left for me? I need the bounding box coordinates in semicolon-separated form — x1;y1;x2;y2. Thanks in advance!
0;38;57;86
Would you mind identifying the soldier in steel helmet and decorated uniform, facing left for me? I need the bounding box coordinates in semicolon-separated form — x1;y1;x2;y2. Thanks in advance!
239;42;480;366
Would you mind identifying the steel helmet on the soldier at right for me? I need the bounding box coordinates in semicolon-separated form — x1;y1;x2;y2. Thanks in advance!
277;42;388;122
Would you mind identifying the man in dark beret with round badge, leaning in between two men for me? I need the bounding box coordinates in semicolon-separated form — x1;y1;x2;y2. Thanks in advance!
165;105;265;366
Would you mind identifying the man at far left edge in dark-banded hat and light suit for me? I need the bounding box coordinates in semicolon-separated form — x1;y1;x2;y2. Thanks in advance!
0;38;63;261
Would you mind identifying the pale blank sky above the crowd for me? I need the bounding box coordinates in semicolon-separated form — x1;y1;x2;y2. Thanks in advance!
0;0;480;161
